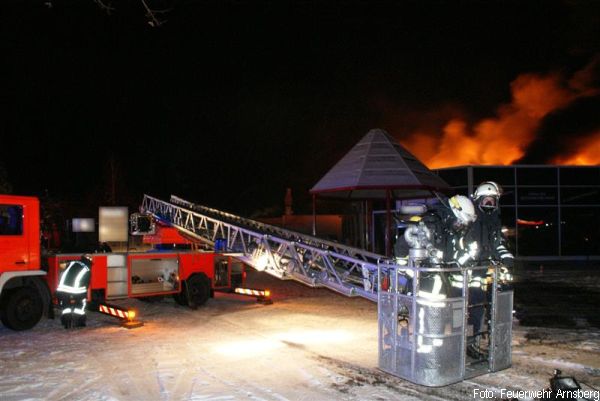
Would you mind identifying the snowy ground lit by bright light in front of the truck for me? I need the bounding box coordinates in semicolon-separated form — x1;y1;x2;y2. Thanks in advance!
0;273;600;401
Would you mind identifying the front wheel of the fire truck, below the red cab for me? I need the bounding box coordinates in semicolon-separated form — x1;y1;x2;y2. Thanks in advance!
2;287;43;330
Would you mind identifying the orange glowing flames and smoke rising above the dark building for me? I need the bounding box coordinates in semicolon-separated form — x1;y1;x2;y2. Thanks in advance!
401;60;600;168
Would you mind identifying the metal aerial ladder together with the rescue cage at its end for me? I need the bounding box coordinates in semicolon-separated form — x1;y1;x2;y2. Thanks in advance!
142;195;513;386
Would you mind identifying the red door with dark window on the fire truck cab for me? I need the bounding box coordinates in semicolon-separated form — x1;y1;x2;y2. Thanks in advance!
0;203;31;271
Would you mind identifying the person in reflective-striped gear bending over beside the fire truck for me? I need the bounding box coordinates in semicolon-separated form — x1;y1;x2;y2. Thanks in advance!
56;256;91;329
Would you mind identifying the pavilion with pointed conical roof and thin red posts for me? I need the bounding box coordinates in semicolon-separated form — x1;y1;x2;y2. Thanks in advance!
310;129;452;256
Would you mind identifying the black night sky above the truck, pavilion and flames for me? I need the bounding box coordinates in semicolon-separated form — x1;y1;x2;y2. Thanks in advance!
0;0;600;214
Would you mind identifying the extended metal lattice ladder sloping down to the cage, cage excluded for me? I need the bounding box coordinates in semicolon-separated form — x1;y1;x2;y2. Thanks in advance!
142;195;390;302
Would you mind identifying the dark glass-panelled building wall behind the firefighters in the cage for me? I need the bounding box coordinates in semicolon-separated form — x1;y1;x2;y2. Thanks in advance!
436;165;600;260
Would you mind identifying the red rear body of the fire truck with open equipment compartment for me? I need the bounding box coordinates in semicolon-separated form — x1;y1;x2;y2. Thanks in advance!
47;251;245;308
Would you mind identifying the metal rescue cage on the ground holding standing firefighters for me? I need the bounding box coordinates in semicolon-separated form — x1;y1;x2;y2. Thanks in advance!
378;264;513;387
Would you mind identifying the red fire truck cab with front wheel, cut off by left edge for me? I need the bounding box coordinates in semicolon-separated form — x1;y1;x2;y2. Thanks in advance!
0;195;52;330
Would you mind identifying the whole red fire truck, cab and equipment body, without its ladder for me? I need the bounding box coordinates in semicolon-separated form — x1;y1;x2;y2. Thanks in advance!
0;195;245;330
